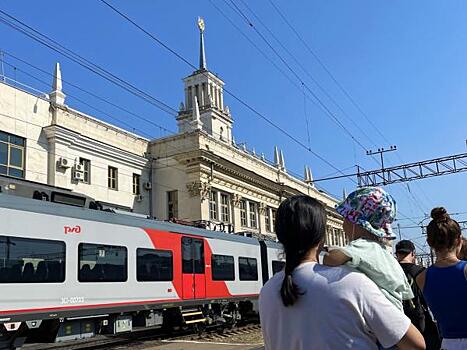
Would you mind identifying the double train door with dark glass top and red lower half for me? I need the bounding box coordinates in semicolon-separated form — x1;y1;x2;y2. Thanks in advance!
182;237;206;299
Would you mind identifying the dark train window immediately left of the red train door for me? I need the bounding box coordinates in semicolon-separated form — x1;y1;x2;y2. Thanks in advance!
136;248;173;282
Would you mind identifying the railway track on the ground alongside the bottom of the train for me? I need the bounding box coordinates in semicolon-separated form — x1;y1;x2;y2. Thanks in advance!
21;323;261;350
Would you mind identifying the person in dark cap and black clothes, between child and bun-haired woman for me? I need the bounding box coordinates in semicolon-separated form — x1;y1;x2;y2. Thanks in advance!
396;239;441;350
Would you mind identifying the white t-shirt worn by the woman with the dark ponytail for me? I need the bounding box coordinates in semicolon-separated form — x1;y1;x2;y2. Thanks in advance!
259;263;410;350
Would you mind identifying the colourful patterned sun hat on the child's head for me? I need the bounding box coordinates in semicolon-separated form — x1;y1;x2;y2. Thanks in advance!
336;187;396;239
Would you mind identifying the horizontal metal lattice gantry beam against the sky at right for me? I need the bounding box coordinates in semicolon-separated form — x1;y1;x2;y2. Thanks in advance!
357;153;467;187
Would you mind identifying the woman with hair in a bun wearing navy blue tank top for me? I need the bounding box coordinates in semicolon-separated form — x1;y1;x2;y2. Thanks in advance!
417;208;467;350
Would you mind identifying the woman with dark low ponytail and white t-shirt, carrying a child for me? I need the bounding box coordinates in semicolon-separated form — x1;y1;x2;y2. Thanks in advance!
259;195;425;350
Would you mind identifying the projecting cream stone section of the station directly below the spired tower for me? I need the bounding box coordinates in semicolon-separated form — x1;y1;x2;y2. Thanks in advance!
150;130;344;245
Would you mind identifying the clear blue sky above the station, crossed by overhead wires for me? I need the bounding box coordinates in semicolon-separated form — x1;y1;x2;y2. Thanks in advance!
0;0;467;252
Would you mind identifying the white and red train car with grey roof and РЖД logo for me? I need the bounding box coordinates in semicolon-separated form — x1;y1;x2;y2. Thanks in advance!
0;194;262;349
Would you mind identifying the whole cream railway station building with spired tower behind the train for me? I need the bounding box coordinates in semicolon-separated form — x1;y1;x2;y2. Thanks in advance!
0;20;345;246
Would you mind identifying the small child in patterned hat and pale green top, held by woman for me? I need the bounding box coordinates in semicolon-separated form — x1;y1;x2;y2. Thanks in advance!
324;187;414;312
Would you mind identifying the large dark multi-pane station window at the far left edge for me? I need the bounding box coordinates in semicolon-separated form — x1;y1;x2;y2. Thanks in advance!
0;131;26;178
